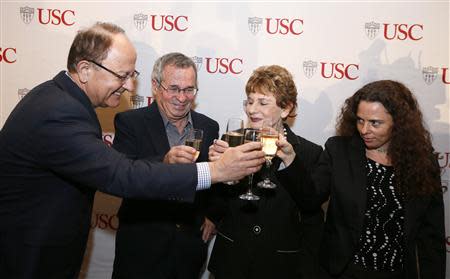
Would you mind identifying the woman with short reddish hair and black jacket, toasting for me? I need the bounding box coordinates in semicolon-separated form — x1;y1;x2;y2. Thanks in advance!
209;65;323;279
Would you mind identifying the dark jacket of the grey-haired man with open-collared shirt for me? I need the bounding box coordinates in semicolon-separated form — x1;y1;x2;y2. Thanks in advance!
113;102;219;277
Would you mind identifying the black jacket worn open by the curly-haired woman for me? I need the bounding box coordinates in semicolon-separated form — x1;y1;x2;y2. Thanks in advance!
297;136;445;279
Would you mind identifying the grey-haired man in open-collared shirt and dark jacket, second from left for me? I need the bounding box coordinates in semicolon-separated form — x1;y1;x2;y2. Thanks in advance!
113;53;219;279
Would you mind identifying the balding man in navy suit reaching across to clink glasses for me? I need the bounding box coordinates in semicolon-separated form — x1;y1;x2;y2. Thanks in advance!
0;23;264;278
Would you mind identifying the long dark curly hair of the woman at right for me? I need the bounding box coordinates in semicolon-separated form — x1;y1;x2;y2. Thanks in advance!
336;80;441;197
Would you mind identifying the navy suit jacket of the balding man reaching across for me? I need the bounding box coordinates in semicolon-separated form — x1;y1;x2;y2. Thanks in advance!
0;72;197;278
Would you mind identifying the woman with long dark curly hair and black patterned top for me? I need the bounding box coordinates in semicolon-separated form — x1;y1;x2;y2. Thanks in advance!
292;80;445;279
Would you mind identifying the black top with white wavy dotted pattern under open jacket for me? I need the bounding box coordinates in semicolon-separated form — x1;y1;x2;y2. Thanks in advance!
353;158;405;271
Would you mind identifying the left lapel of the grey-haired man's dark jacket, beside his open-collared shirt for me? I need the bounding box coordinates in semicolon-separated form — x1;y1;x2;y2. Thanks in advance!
145;101;170;155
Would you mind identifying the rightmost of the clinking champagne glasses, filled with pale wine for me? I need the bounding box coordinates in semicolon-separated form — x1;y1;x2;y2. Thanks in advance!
256;119;283;189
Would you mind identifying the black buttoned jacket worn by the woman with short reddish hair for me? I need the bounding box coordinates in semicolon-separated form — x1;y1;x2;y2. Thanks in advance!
208;126;323;279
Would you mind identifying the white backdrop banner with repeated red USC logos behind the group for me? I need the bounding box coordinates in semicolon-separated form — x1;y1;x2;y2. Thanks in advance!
0;0;450;278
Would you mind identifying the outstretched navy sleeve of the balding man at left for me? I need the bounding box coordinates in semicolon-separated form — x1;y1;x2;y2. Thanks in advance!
36;104;197;201
